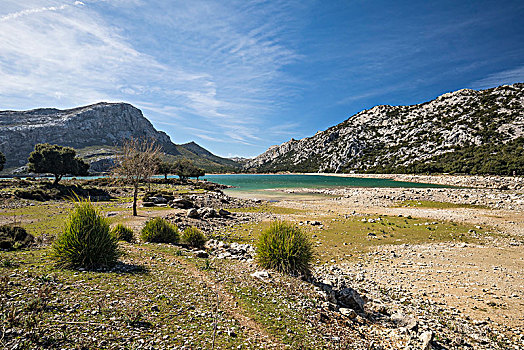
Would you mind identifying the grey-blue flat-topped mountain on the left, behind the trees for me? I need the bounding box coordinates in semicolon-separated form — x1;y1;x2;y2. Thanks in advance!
0;102;239;171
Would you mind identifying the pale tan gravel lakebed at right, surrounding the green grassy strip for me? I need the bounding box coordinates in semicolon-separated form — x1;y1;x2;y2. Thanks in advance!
251;175;524;349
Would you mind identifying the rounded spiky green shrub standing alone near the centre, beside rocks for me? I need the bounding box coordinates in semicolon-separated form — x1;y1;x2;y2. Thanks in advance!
256;221;313;274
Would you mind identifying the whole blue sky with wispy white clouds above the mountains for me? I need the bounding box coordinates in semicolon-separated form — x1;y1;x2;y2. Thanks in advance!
0;0;524;157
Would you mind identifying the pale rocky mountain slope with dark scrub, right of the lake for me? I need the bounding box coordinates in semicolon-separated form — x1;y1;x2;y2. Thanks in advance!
244;83;524;174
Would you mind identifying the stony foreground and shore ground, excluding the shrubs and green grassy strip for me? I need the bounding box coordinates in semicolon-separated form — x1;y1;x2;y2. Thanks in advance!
0;176;524;349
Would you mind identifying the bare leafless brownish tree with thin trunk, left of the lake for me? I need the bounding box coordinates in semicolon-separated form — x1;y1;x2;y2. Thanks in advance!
112;138;160;216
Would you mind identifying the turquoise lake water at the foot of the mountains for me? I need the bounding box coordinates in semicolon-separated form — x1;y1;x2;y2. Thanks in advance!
205;174;446;191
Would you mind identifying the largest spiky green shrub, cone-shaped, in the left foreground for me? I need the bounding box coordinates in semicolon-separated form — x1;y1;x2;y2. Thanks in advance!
51;200;120;269
